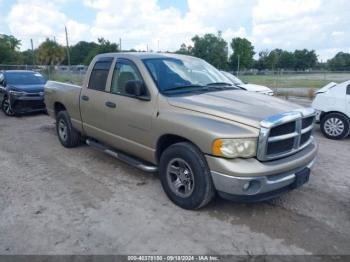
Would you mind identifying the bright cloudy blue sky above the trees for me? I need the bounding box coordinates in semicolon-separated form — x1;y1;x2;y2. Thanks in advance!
0;0;350;61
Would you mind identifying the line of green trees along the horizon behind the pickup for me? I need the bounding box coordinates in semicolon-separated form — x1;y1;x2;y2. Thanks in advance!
0;32;350;71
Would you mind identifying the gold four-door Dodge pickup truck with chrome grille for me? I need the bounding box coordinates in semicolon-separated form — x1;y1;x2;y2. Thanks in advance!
45;53;317;209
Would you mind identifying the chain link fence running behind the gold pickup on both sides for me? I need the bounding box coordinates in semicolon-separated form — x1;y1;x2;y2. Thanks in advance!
0;64;350;98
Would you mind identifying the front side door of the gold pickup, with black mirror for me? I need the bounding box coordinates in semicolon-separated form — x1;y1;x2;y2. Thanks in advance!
100;58;156;159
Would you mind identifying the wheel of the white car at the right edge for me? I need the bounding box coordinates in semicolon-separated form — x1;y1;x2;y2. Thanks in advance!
321;113;350;140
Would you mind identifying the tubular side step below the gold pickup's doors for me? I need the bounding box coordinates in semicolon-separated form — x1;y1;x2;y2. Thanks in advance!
86;139;158;173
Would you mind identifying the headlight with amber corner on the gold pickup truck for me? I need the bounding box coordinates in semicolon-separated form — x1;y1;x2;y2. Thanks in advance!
212;138;257;158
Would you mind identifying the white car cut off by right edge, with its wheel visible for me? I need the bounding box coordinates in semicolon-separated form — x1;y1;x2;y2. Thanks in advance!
312;80;350;139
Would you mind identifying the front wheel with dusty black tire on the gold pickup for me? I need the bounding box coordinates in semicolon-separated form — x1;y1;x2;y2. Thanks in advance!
159;142;215;210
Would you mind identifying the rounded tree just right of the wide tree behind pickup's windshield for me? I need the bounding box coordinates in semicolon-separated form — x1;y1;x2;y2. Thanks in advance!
230;37;255;70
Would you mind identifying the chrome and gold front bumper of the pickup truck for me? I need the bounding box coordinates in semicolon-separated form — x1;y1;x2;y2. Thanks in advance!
207;143;317;202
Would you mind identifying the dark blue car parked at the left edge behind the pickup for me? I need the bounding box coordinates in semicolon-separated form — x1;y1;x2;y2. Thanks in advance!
0;70;46;116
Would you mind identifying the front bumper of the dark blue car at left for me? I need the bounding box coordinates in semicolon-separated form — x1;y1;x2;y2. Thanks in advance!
10;96;45;114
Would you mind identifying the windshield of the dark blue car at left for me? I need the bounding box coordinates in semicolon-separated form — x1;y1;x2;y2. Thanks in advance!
6;72;46;85
